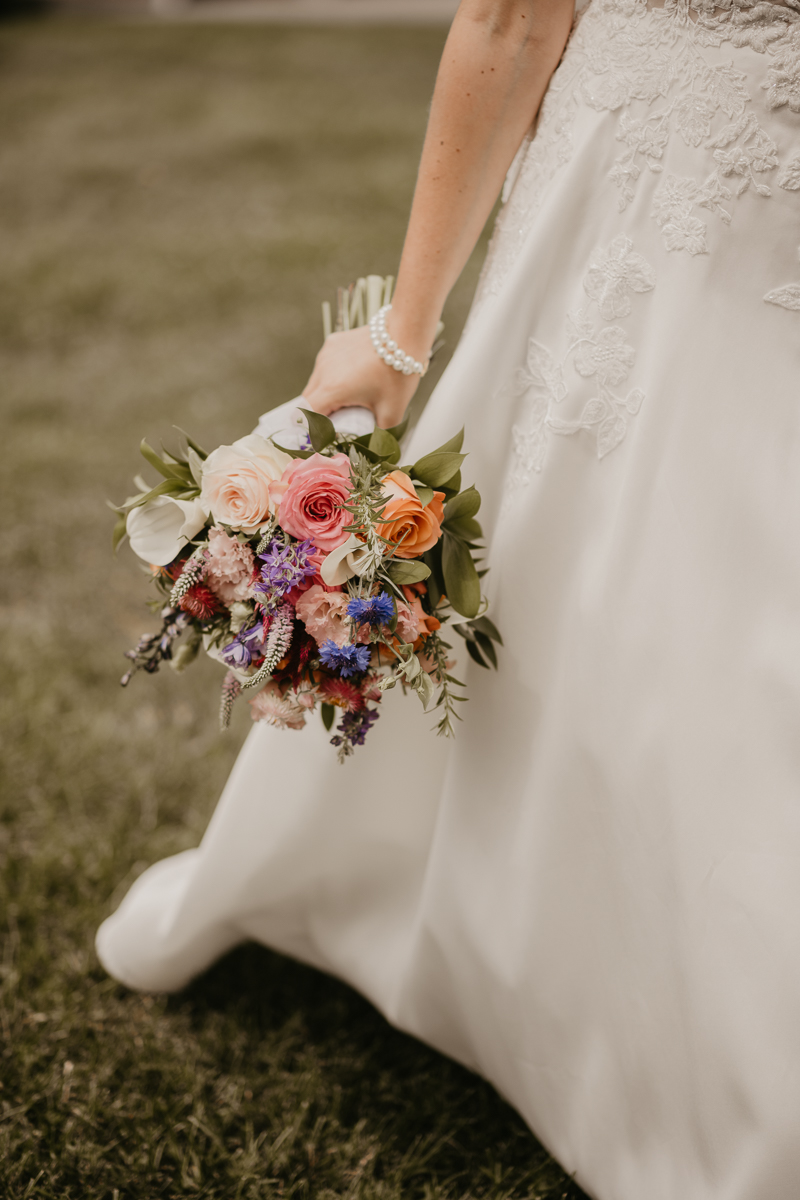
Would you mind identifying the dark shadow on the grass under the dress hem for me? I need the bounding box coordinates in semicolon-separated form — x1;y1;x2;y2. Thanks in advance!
168;943;585;1200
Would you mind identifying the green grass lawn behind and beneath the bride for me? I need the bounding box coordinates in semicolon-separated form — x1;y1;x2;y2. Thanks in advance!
0;22;581;1200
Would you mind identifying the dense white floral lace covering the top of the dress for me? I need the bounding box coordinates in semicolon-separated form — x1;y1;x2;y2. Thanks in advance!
479;0;800;307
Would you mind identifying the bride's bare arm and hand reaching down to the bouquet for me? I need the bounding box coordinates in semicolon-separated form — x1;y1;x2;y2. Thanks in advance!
303;0;573;426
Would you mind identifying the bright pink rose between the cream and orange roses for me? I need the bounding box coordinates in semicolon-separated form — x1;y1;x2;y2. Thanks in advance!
270;454;350;552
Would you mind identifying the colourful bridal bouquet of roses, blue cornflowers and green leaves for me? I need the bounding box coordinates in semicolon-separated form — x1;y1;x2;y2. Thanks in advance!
115;279;500;760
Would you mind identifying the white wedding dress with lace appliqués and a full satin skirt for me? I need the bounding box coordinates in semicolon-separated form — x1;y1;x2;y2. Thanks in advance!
97;0;800;1200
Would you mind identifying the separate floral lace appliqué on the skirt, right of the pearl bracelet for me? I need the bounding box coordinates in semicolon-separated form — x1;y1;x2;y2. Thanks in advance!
495;236;656;508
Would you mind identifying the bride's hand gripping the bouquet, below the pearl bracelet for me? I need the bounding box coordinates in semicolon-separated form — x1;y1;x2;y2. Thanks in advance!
302;325;420;430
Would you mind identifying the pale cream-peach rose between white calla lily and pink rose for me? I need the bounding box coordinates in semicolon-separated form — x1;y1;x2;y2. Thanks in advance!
200;433;291;534
